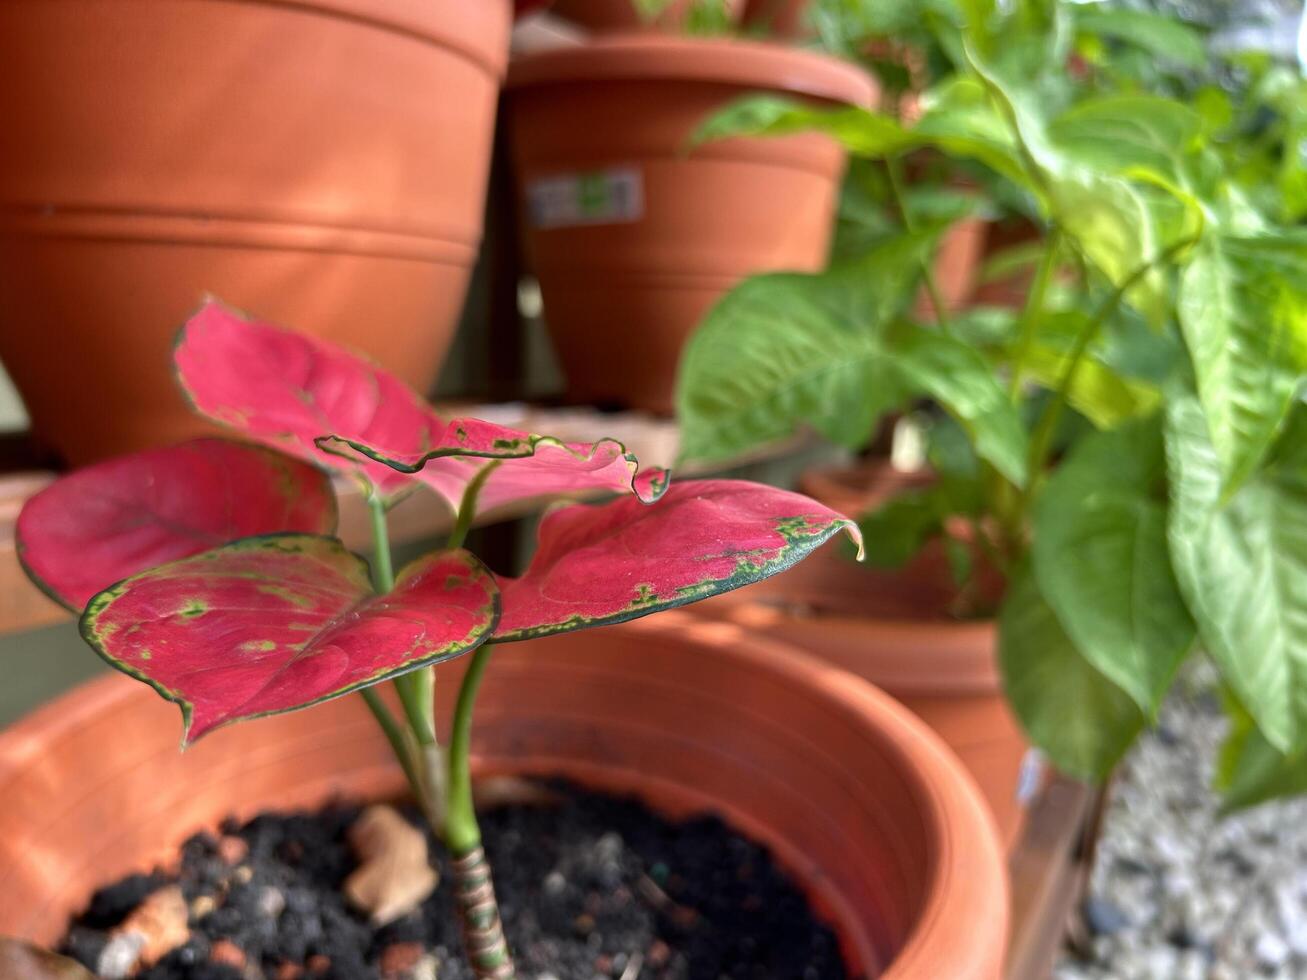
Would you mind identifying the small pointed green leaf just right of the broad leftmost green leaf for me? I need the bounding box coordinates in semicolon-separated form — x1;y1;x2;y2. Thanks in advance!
887;324;1030;486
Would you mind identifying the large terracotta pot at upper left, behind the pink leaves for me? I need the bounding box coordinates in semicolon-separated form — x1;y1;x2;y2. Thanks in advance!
0;0;512;463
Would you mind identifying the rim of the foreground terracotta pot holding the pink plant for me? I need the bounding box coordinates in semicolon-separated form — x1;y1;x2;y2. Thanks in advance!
0;613;1005;977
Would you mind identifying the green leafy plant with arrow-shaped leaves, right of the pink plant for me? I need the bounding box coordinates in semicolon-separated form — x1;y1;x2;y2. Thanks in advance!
678;1;1307;802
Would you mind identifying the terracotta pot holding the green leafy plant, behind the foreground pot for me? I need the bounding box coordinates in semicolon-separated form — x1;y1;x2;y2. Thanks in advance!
695;464;1040;848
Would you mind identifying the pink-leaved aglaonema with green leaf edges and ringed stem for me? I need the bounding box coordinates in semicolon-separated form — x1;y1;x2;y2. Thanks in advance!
17;302;857;979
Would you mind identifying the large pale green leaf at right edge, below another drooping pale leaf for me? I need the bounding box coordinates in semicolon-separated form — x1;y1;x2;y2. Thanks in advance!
1166;397;1307;751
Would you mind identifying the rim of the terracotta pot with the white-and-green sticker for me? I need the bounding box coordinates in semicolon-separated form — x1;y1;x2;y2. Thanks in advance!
506;33;878;107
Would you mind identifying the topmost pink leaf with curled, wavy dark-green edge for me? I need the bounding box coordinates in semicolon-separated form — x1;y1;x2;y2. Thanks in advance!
174;301;667;510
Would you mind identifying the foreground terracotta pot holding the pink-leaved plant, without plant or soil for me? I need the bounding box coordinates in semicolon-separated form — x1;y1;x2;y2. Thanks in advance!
0;613;1008;980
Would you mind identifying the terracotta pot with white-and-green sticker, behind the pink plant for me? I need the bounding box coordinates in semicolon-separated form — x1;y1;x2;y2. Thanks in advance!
508;35;876;413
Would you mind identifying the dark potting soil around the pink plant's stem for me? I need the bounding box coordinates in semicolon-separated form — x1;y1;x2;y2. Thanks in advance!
63;787;846;980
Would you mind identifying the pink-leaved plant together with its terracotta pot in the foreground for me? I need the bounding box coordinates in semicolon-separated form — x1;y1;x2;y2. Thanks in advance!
0;303;1005;980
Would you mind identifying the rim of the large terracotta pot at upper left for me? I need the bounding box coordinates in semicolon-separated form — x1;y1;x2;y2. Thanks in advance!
249;0;514;80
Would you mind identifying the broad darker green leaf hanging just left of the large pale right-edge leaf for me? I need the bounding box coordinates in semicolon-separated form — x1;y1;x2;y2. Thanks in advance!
1033;417;1195;717
